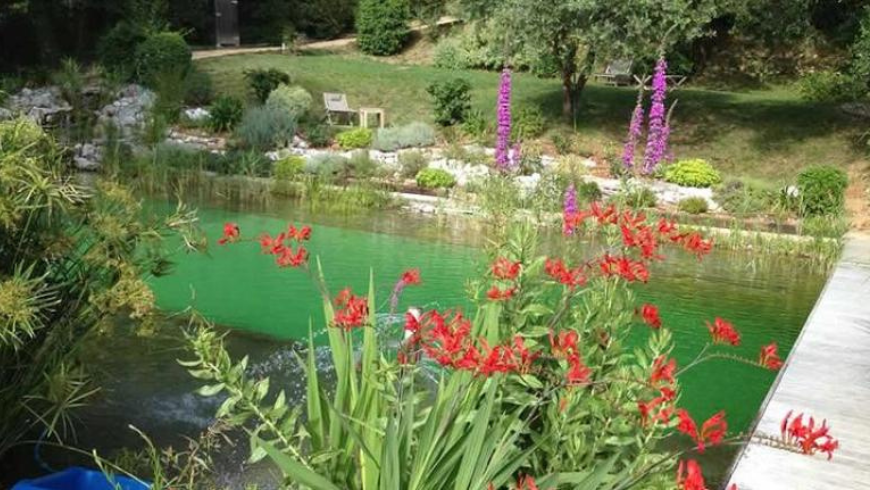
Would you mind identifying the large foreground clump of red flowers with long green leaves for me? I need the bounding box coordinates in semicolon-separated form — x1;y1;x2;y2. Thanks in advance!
183;198;836;490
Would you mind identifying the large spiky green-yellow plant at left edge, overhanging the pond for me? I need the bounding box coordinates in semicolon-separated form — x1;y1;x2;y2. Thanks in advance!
0;119;202;464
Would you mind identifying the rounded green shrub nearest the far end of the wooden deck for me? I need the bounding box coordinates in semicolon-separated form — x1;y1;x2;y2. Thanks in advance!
798;165;849;216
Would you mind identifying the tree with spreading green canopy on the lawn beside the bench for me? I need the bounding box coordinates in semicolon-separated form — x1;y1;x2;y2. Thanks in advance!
460;0;717;117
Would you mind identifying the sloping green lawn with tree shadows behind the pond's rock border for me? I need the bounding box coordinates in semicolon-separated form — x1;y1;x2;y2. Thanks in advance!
197;52;865;183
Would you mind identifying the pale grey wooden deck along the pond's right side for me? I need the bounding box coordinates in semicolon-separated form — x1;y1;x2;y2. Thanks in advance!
728;235;870;490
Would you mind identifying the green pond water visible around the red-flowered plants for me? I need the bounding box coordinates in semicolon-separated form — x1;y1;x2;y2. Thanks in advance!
63;194;825;486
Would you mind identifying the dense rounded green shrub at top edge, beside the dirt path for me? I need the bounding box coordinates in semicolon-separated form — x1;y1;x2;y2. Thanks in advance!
356;0;411;56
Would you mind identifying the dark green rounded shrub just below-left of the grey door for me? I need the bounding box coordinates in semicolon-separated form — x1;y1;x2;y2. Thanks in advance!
135;32;191;86
